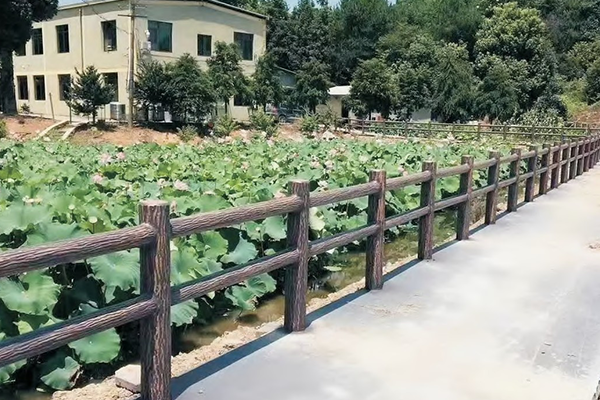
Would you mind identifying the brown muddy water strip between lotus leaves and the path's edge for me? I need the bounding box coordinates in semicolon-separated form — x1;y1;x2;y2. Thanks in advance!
0;212;456;400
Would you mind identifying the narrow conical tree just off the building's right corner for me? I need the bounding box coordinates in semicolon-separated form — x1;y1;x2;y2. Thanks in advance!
252;53;283;110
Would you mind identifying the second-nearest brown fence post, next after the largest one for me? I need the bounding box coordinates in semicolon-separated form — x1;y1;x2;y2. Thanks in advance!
283;180;310;332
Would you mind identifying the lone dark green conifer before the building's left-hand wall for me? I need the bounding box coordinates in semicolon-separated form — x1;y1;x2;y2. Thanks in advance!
67;65;114;124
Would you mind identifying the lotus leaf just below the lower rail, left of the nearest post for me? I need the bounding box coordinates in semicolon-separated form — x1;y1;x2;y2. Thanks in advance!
69;328;121;364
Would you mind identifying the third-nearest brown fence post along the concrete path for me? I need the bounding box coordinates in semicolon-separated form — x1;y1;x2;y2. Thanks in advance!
365;169;385;290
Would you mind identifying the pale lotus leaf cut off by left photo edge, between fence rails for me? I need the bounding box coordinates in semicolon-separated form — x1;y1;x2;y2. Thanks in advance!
0;271;60;315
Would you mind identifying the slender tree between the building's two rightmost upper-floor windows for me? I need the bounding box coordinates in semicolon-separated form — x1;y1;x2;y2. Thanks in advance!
208;42;248;113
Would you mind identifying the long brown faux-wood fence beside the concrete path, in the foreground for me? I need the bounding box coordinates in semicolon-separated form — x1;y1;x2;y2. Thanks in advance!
0;136;600;400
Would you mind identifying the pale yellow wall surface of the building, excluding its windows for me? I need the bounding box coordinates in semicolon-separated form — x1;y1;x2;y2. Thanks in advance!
13;0;266;120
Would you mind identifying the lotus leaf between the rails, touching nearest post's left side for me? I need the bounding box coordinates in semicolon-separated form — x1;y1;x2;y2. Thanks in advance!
87;251;140;303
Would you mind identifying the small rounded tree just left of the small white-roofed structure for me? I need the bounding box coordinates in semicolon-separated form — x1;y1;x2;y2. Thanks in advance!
295;61;332;112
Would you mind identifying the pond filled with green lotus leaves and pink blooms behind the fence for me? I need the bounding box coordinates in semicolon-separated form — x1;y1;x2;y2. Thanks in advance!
0;136;510;390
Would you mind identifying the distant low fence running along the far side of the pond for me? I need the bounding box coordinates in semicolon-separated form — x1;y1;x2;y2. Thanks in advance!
339;118;600;140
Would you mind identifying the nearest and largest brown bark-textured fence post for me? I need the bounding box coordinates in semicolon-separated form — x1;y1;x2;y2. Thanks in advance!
139;200;171;400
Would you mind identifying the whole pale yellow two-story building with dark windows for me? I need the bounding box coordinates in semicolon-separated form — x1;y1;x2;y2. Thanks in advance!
13;0;267;120
